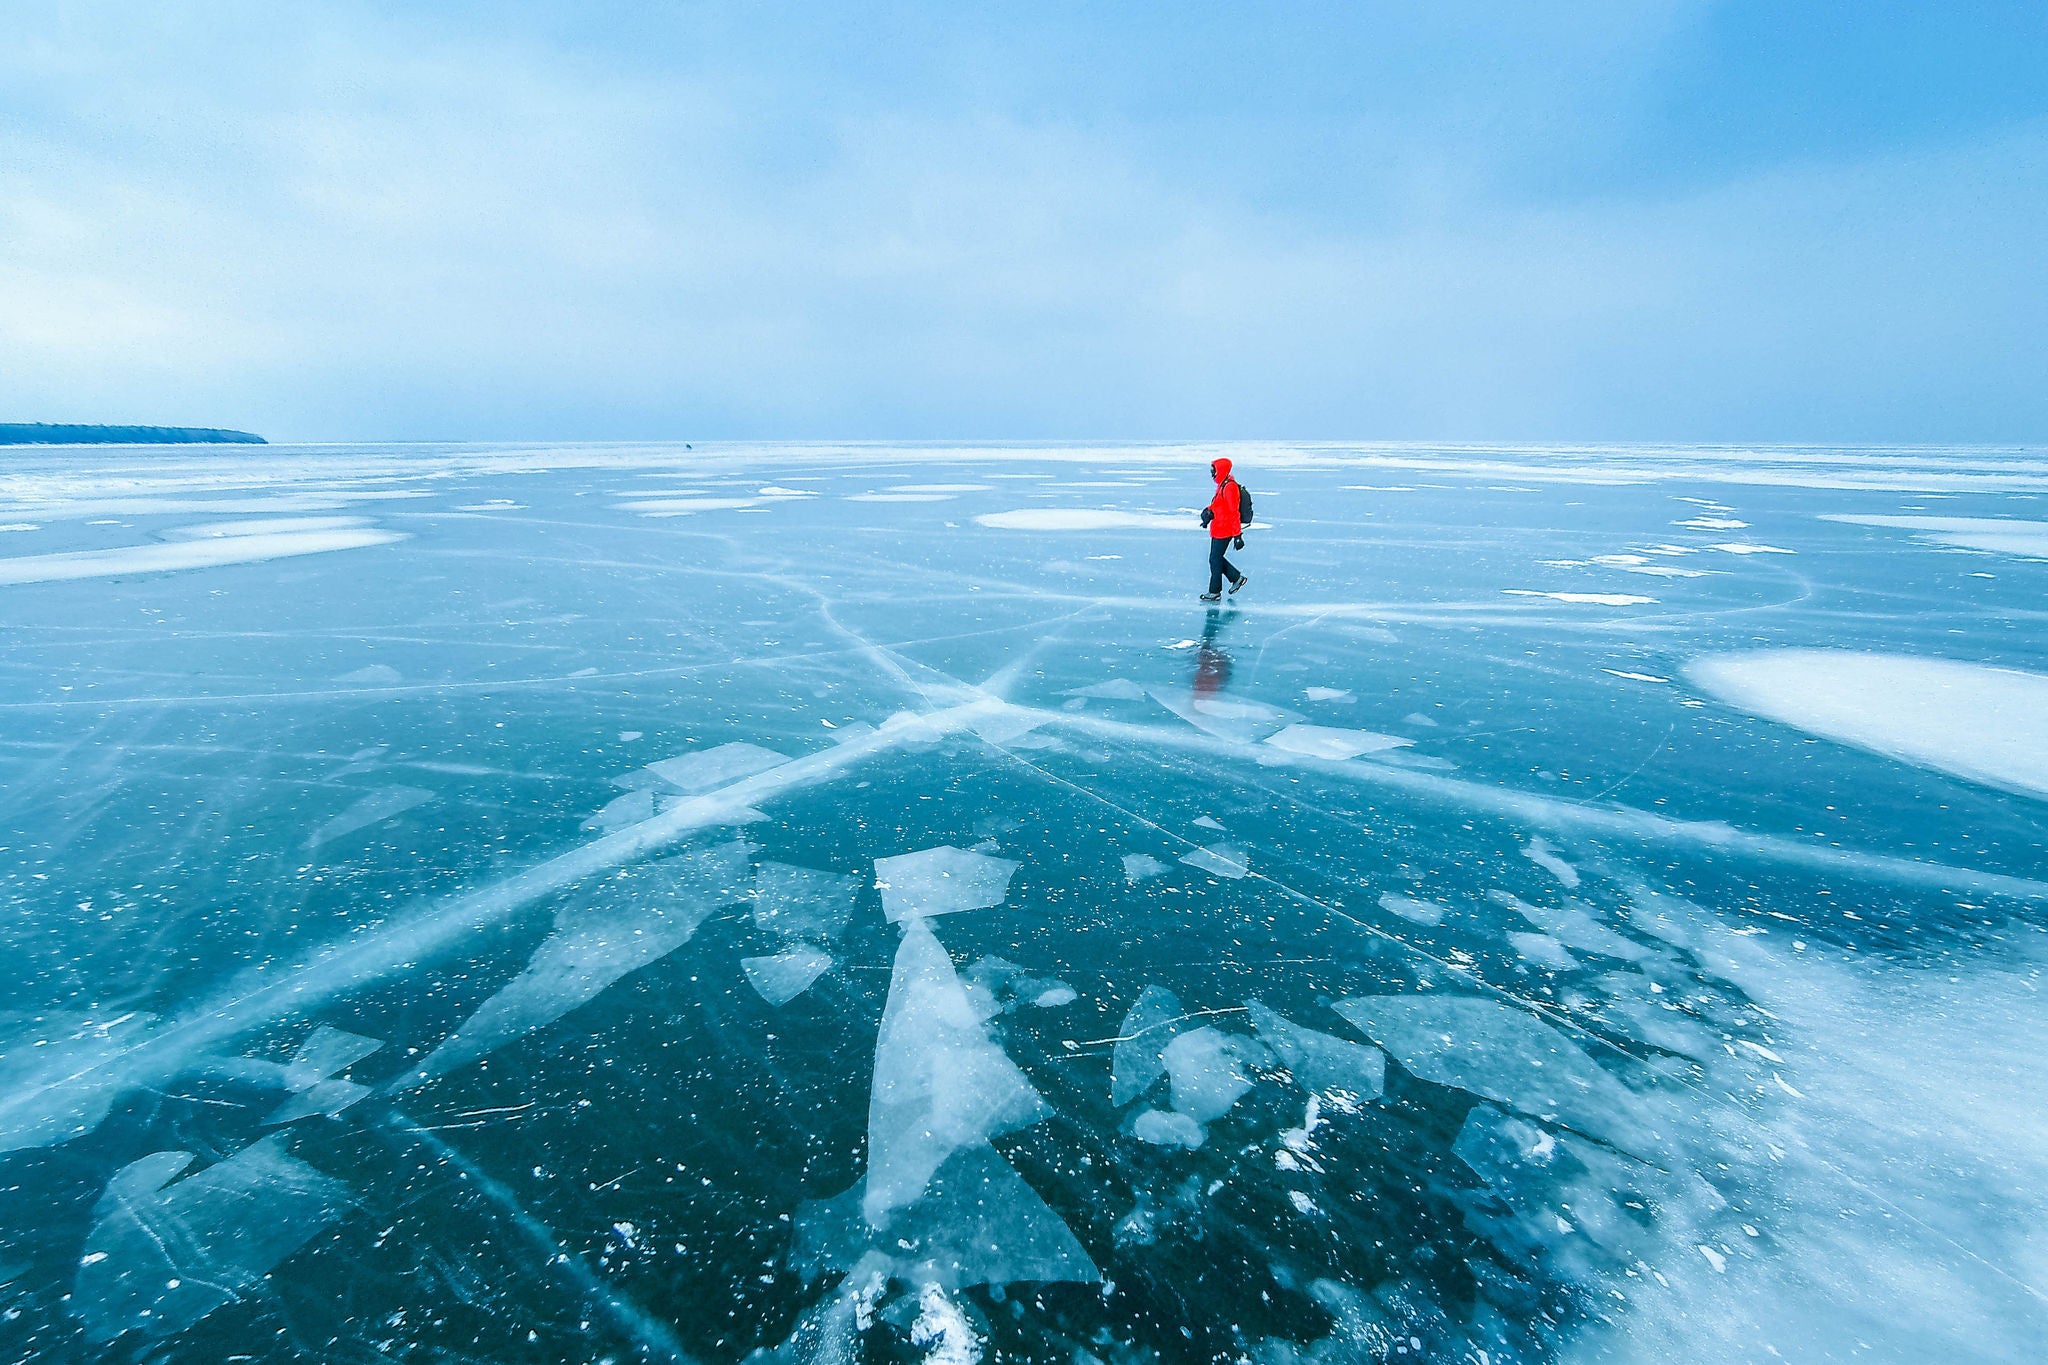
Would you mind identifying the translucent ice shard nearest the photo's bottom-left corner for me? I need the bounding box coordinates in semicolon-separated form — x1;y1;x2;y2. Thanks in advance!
72;1138;354;1342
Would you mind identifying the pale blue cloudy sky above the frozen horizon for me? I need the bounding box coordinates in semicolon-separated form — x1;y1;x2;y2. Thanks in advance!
0;0;2048;444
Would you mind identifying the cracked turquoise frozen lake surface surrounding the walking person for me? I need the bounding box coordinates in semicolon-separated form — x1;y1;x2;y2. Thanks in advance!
0;444;2048;1365
